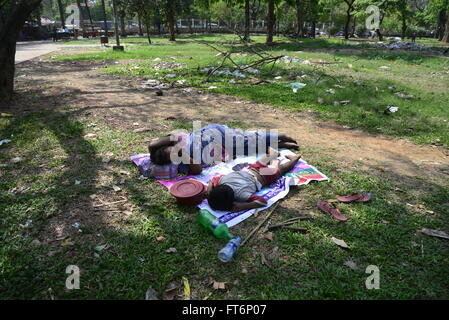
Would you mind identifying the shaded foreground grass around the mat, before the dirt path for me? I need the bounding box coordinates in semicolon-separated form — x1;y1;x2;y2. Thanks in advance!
0;111;449;299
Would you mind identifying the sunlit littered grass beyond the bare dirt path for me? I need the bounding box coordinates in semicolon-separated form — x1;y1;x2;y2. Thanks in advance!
59;35;449;147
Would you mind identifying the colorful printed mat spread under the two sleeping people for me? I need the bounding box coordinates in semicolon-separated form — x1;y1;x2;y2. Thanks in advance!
131;150;329;227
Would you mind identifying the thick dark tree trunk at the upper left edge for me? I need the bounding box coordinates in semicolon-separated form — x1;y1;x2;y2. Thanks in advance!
0;0;42;99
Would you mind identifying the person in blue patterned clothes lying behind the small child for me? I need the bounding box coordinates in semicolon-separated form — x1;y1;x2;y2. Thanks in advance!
148;124;299;177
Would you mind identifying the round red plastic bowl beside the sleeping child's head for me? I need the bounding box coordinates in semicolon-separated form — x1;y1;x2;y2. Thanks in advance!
170;179;206;206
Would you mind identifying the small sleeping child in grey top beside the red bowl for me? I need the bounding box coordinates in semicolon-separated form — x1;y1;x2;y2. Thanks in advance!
207;148;301;212
